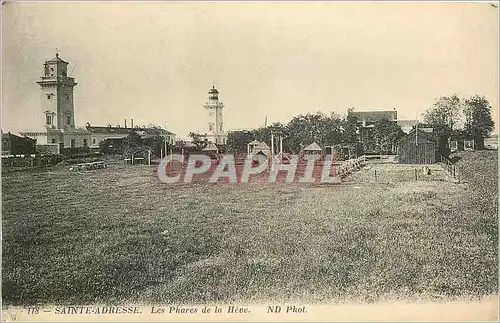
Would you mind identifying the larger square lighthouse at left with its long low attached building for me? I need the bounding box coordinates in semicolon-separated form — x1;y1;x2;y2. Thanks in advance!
21;53;175;151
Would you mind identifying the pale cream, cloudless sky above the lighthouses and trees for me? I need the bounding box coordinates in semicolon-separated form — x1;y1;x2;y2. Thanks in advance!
2;2;499;137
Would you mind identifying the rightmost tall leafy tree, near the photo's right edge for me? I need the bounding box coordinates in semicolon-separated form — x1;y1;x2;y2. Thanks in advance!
464;95;495;149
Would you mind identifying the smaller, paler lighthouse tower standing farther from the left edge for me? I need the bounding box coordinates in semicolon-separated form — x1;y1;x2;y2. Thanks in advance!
203;86;226;145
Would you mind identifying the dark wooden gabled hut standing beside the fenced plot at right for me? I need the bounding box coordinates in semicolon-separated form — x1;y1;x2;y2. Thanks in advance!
397;129;436;164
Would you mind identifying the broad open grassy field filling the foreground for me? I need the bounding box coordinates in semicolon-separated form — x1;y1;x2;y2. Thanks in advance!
2;152;498;305
